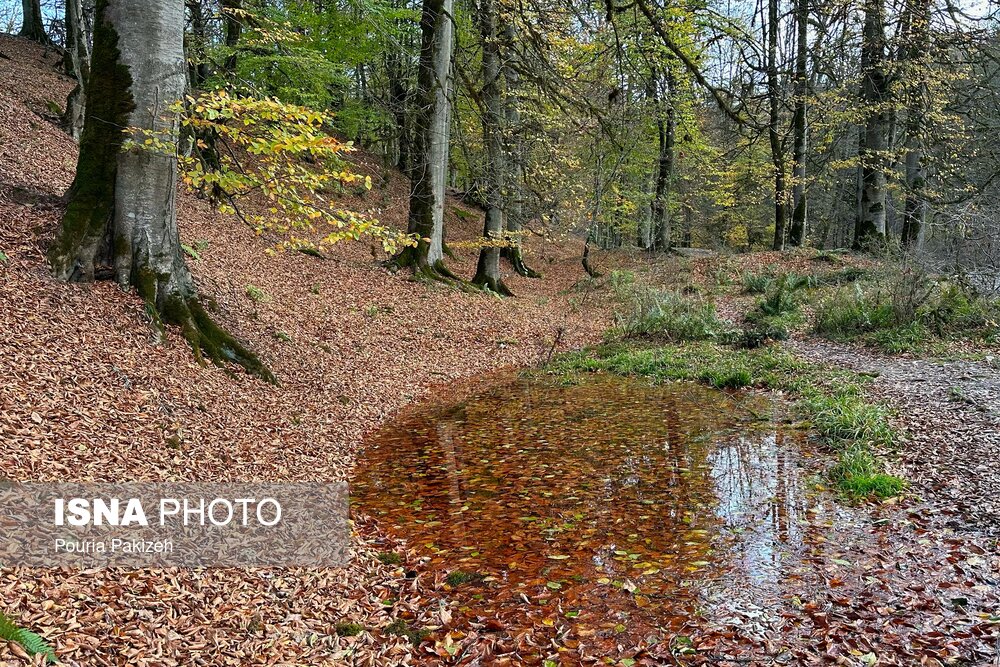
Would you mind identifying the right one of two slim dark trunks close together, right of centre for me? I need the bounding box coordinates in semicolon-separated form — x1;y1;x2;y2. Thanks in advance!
788;0;809;247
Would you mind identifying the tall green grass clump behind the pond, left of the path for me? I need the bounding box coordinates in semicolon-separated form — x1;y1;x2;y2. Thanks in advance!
611;274;733;342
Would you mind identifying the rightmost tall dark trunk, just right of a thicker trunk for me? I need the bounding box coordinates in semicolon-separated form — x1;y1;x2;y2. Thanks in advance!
902;0;930;248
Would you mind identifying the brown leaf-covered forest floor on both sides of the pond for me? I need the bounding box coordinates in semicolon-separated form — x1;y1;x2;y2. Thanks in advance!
0;36;1000;666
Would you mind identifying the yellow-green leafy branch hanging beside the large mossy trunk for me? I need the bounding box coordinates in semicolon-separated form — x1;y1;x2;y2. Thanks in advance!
126;90;414;253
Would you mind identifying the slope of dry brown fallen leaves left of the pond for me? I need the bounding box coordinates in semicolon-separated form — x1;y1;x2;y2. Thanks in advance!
0;37;608;665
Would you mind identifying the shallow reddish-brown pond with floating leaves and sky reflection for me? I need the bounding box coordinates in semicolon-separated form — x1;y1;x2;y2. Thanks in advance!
352;374;836;659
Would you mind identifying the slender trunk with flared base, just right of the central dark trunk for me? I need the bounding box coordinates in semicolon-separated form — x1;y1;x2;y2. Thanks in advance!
501;23;542;278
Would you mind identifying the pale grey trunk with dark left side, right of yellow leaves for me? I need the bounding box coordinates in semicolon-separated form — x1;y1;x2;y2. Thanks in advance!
392;0;454;278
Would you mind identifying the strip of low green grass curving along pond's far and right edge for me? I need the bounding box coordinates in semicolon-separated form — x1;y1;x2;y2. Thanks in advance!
550;342;905;499
